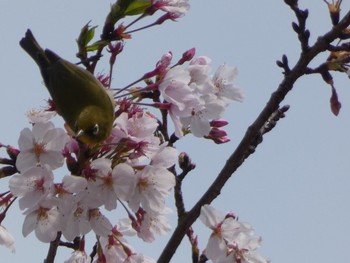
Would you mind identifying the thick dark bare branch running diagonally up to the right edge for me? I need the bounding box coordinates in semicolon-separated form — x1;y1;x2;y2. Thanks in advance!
158;9;350;263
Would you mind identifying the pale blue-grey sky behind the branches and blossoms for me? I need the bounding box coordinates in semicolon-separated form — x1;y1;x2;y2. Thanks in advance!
0;0;350;263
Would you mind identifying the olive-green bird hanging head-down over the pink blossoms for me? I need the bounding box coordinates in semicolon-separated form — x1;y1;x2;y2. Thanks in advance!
19;29;114;145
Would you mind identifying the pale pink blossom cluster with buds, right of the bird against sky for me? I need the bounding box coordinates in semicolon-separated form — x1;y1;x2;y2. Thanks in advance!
142;52;243;143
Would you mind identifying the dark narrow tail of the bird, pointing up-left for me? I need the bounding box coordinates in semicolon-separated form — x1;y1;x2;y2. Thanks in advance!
19;29;51;70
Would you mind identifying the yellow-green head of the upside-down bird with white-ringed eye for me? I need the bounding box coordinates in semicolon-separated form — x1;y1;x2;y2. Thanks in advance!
74;106;113;145
